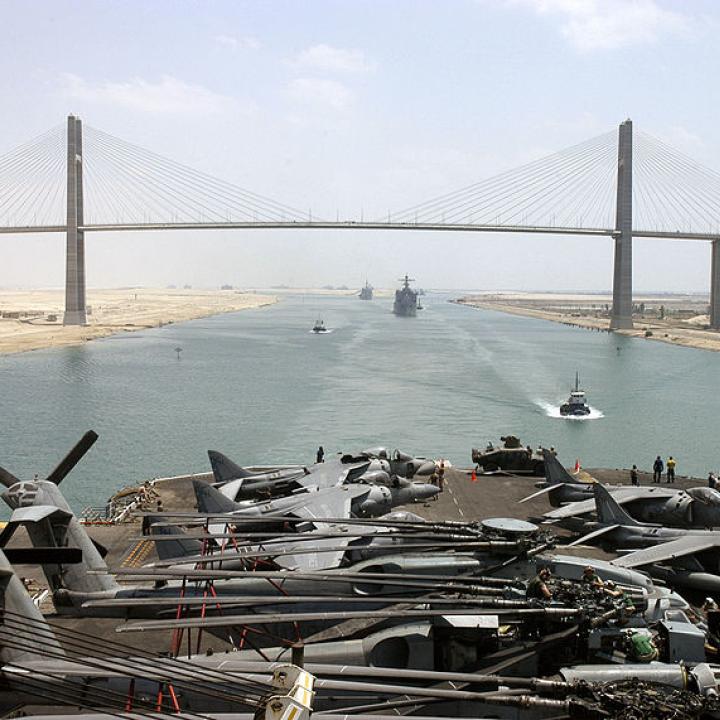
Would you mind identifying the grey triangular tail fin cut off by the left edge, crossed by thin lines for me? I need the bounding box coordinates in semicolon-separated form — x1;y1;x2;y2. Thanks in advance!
0;550;65;665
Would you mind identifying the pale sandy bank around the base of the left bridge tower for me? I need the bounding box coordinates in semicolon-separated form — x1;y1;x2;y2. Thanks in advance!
0;288;277;354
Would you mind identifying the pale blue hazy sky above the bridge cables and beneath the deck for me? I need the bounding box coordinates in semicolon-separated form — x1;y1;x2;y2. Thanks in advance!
0;0;720;291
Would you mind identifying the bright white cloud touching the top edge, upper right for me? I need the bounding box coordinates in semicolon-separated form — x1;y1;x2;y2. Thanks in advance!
511;0;689;51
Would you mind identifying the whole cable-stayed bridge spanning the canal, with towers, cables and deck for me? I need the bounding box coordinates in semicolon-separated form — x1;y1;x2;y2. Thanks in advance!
0;115;720;329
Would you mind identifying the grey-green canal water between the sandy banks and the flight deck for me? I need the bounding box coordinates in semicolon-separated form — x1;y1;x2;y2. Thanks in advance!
0;295;720;509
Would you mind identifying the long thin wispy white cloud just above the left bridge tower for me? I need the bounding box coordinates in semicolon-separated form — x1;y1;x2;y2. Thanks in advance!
62;73;235;114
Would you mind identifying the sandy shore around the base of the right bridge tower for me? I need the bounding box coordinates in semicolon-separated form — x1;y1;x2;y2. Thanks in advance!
456;293;720;352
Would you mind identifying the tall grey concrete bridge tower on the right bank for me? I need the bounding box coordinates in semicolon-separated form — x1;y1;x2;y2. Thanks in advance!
610;120;633;330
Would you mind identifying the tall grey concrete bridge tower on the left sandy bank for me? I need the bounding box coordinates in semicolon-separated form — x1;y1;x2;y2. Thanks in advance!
63;115;87;325
